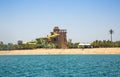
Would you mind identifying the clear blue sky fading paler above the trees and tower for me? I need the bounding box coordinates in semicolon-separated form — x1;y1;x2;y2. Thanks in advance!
0;0;120;43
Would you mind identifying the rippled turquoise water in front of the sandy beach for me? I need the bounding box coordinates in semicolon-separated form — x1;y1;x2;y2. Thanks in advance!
0;55;120;77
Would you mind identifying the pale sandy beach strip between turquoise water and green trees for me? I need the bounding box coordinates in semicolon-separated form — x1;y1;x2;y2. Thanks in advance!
0;48;120;55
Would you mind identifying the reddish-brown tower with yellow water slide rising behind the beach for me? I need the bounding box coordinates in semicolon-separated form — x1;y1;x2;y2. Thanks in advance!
45;26;67;48
